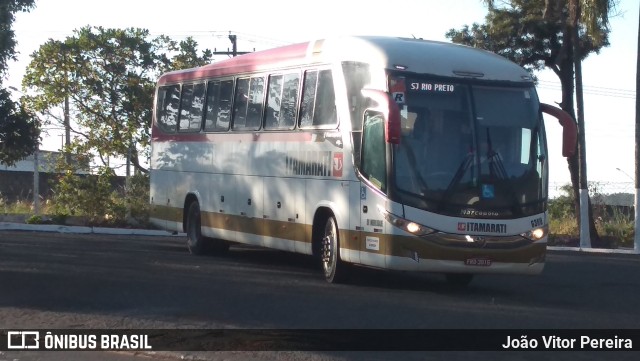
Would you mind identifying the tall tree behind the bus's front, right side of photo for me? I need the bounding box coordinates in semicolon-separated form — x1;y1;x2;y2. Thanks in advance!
446;0;615;245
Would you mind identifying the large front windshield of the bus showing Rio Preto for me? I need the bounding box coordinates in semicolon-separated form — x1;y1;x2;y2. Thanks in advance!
393;75;547;218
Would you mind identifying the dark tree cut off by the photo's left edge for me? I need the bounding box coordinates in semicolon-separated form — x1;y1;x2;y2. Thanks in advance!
0;0;38;165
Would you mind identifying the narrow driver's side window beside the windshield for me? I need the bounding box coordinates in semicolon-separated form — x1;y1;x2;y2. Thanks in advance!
361;110;387;191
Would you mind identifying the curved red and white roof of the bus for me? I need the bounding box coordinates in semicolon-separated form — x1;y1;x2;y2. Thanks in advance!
158;36;531;85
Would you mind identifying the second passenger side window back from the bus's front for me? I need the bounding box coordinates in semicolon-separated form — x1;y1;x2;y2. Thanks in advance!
265;73;300;129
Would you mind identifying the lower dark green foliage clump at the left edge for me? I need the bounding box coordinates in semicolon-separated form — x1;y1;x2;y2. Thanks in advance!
0;89;39;166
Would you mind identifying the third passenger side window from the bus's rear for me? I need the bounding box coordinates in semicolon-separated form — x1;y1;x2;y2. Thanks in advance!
205;80;233;132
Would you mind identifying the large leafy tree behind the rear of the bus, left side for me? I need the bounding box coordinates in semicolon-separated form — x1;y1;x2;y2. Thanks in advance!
23;27;211;172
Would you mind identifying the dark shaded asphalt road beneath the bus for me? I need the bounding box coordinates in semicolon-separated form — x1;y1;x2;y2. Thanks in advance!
0;231;640;361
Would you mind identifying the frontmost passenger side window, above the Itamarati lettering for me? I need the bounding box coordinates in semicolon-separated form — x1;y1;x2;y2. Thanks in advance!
300;69;338;128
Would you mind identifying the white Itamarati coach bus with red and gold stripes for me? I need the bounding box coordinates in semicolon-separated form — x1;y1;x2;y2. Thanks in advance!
150;36;577;285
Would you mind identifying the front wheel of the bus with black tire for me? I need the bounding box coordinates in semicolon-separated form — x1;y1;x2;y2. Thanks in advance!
320;216;350;283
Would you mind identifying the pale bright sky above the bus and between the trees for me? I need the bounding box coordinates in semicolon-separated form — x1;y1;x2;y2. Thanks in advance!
4;0;640;194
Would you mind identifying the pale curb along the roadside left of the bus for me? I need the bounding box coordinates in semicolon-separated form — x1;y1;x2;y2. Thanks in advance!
0;222;185;237
